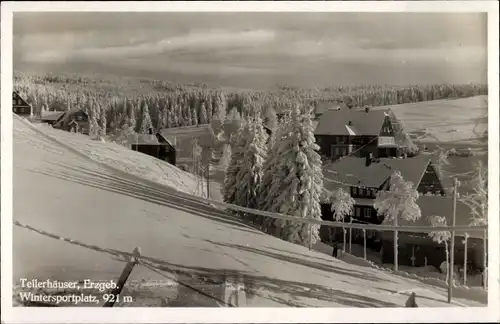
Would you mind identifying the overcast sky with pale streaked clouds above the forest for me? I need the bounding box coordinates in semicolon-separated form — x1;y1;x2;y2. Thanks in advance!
14;13;487;88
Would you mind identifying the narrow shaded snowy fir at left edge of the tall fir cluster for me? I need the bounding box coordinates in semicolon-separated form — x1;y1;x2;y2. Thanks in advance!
222;119;248;204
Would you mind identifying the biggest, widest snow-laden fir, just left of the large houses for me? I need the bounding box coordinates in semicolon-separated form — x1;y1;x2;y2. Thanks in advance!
258;106;323;246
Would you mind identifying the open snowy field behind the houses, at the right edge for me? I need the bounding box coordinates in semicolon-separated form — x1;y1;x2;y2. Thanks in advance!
373;96;488;144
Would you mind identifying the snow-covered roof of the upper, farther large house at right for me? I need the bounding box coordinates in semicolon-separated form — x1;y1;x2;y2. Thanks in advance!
314;108;389;136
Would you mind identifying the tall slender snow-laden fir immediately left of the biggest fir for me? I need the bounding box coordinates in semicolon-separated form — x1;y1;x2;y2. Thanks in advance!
234;115;268;213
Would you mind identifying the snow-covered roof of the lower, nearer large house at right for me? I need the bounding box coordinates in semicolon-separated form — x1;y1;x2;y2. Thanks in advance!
323;155;431;190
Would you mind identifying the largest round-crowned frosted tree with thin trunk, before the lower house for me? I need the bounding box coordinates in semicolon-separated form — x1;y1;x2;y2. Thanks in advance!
373;171;422;271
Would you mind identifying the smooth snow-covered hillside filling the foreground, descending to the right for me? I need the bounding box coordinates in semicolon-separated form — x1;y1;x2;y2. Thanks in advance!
13;118;482;307
